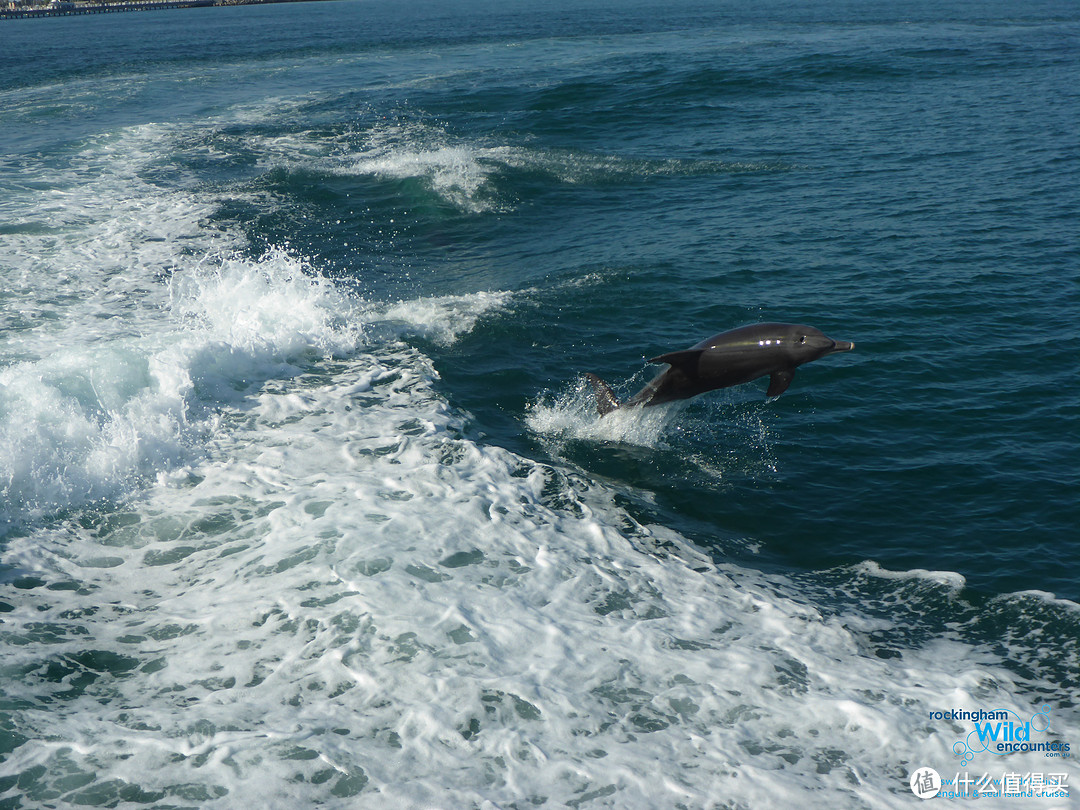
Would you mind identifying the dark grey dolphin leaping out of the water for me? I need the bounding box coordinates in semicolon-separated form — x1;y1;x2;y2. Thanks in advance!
585;323;855;416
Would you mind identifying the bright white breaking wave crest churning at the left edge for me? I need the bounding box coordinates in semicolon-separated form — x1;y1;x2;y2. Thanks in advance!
0;253;362;522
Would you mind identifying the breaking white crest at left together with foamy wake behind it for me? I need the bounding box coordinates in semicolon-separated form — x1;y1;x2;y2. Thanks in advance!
0;117;518;524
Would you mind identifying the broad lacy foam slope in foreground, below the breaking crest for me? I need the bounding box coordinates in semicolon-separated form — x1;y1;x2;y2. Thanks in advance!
4;343;1076;808
